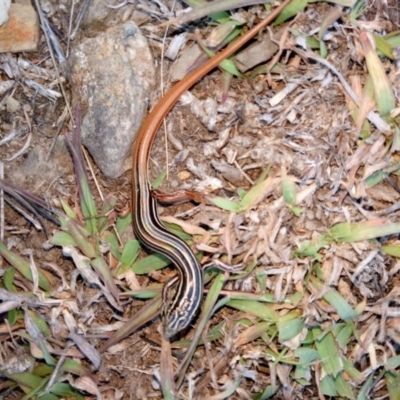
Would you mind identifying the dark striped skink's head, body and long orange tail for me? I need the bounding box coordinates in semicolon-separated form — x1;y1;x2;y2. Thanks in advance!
132;0;291;339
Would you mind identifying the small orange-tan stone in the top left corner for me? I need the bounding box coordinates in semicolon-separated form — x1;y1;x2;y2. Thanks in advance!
0;4;40;53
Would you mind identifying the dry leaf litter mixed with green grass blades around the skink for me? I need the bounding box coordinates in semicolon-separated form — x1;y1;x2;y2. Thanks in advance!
0;0;400;399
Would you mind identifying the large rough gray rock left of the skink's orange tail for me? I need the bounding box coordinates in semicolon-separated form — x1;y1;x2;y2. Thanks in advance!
69;22;155;179
